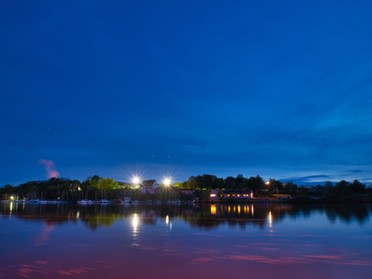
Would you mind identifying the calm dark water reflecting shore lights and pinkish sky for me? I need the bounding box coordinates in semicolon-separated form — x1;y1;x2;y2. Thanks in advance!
0;204;372;279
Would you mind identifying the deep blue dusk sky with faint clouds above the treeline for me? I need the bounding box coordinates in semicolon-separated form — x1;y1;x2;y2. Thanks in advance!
0;0;372;185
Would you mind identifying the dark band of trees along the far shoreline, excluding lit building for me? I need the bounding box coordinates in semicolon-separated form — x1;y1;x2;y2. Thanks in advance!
0;174;372;202
